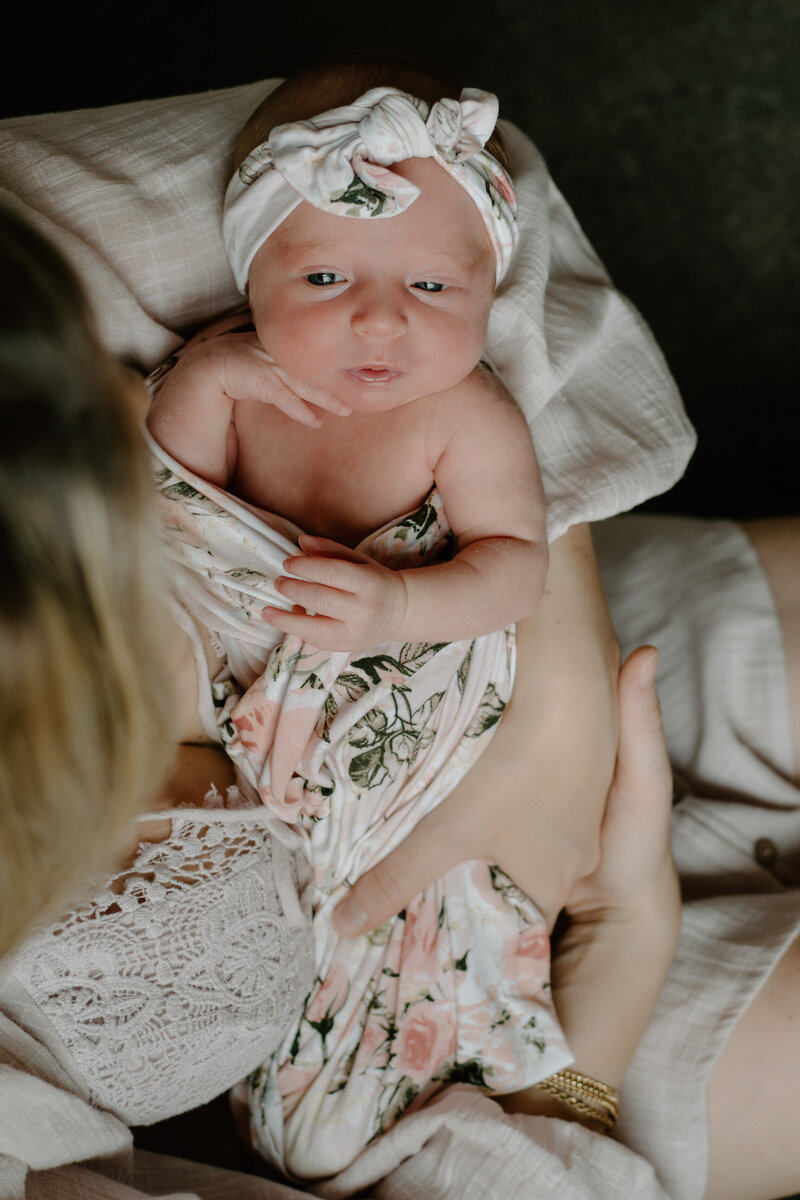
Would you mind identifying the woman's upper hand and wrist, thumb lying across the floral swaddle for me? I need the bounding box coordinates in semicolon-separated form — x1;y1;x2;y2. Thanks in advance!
336;526;619;935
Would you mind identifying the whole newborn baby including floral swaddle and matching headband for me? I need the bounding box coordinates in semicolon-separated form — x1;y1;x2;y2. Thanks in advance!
148;58;570;1177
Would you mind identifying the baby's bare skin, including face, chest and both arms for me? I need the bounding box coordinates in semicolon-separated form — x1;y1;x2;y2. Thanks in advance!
148;160;548;650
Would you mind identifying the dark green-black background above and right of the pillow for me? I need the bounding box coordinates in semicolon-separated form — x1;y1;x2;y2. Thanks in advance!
1;0;800;516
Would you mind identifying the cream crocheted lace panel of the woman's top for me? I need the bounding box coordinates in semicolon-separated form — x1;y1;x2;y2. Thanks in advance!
11;802;312;1124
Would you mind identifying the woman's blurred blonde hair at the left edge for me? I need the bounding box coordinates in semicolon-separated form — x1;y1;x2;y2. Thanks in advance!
0;209;173;953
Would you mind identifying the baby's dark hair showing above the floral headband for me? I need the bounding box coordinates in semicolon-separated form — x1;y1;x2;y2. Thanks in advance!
235;54;509;170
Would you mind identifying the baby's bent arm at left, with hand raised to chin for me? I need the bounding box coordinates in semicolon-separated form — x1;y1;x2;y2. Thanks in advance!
148;316;350;487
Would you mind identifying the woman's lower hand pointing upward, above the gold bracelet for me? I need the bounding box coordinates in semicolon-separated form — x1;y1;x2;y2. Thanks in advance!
499;647;680;1116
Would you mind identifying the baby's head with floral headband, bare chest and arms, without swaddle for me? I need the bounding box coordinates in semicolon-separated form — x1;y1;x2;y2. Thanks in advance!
148;68;547;650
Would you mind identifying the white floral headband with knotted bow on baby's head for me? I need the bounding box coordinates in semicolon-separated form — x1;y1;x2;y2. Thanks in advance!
222;88;518;292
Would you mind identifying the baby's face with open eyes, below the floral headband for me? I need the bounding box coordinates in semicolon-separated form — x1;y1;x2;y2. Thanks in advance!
249;158;495;412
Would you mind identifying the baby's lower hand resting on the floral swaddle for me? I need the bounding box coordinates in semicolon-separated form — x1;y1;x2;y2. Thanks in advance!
261;534;408;650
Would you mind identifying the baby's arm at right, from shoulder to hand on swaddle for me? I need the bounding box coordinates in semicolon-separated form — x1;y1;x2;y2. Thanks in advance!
264;367;548;650
